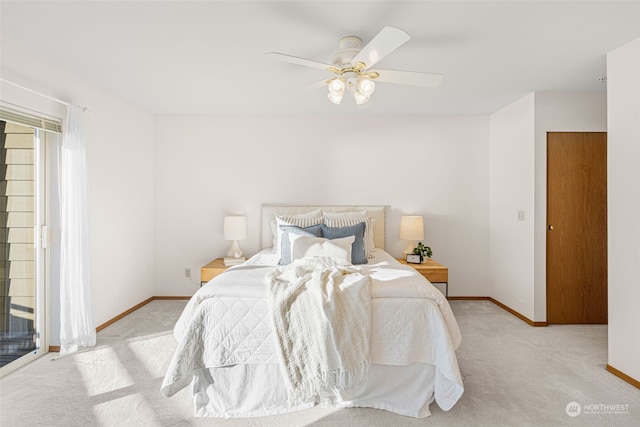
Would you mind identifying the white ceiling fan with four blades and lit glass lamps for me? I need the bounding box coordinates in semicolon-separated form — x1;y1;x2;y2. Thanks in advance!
267;27;444;105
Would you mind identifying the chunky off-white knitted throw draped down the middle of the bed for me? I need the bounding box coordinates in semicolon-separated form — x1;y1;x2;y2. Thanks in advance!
266;257;371;399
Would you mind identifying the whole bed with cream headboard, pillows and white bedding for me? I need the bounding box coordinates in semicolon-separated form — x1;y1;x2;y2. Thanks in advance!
161;205;464;418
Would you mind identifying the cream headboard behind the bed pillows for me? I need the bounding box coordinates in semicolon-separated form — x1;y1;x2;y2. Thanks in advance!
260;204;387;249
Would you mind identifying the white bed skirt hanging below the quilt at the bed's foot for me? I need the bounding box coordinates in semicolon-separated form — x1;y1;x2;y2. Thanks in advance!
192;362;440;418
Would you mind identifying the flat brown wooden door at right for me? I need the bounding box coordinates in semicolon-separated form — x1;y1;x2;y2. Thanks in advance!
547;132;607;324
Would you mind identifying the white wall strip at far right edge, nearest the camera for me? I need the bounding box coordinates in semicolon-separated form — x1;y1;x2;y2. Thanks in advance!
607;39;640;381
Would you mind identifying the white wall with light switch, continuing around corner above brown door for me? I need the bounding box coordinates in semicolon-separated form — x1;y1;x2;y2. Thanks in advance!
490;92;607;322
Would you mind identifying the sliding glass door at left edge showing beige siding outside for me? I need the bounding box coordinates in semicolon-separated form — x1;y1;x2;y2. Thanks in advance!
0;121;47;374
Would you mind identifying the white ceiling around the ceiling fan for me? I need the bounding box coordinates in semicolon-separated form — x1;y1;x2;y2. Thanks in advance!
0;0;640;115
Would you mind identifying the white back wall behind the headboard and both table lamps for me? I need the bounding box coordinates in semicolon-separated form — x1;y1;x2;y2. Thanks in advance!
155;116;489;296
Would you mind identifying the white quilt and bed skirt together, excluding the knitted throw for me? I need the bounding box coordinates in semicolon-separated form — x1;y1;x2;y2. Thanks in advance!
161;249;464;417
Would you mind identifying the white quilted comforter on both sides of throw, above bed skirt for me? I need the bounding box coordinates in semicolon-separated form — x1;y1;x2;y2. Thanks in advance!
161;249;463;410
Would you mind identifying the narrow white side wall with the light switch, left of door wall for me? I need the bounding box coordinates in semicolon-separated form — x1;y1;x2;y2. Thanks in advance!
489;94;536;319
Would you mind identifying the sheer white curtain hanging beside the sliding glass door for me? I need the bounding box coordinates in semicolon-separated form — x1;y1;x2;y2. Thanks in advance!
60;105;96;355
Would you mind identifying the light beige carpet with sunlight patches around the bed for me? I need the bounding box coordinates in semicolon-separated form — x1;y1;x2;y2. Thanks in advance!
0;301;640;427
